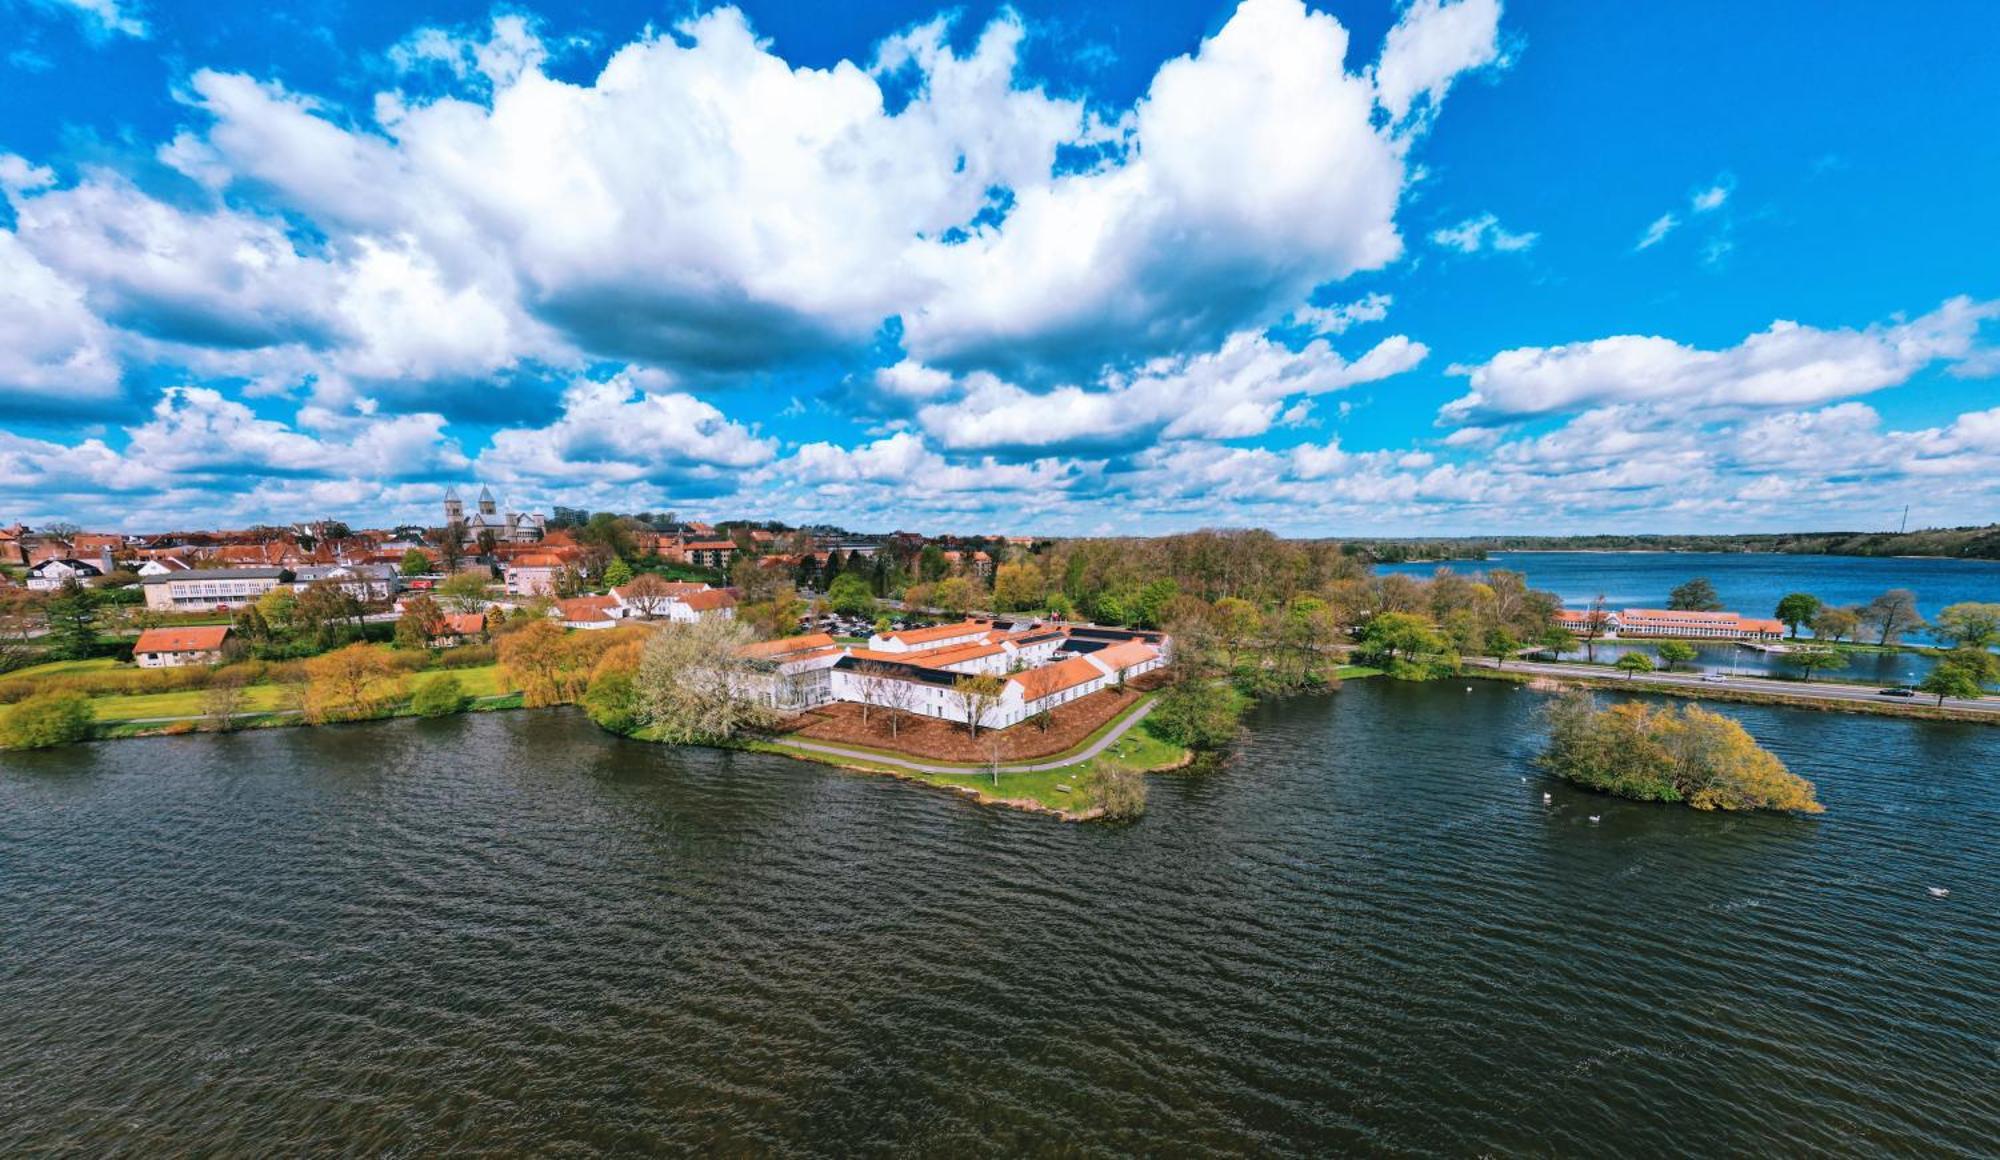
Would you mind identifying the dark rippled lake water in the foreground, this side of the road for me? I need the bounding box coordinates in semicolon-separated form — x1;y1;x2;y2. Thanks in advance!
0;680;2000;1156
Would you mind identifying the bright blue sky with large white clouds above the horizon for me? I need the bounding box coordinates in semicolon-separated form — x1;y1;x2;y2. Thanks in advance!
0;0;2000;536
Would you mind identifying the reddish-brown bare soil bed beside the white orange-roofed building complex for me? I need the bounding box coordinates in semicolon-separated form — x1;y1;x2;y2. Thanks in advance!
784;688;1138;764
